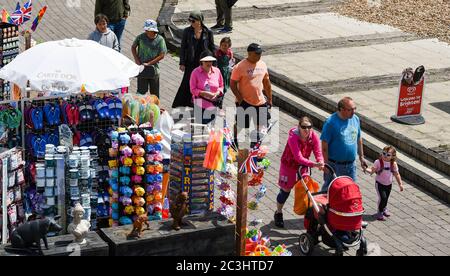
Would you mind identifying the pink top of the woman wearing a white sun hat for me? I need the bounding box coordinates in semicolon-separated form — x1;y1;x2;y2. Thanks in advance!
190;66;223;109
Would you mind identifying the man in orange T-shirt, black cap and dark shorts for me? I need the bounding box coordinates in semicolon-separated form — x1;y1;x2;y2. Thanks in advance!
230;43;272;147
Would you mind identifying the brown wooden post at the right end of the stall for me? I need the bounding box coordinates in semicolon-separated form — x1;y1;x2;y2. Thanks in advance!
235;149;248;256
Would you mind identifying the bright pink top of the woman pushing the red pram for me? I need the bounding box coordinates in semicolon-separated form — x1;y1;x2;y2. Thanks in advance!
281;128;323;174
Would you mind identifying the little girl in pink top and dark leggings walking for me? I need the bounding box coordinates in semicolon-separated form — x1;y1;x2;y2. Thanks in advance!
366;146;403;221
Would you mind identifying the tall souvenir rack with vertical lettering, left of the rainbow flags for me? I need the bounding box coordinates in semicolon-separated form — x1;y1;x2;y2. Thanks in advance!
169;129;214;215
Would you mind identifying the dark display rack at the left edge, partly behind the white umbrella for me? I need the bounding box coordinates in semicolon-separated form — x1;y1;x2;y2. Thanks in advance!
0;23;19;101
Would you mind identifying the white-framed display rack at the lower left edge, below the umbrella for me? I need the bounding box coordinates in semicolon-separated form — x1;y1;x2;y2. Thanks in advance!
0;148;26;244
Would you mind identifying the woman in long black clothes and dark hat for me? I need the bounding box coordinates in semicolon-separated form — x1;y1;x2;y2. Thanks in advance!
172;11;215;108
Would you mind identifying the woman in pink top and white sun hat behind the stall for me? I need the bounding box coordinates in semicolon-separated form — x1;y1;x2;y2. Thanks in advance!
190;51;224;125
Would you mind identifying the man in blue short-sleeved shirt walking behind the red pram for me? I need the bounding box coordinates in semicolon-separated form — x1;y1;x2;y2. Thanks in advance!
320;97;367;191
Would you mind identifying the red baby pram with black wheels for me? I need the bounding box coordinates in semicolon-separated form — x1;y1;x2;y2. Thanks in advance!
299;165;367;256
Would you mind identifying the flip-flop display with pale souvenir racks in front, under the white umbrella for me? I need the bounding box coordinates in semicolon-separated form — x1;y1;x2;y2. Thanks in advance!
25;95;122;230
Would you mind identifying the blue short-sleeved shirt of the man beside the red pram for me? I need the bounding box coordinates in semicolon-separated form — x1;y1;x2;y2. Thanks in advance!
320;113;361;162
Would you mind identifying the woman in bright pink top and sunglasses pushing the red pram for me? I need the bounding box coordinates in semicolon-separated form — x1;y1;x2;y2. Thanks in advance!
274;116;324;227
